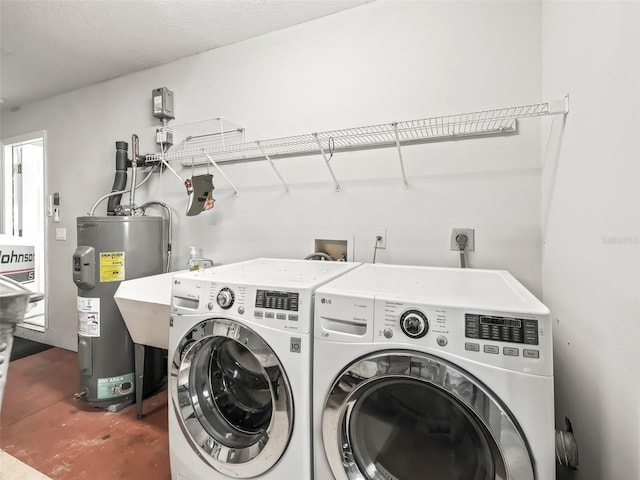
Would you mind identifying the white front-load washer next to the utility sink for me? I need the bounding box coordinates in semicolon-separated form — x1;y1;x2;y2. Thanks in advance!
168;258;358;480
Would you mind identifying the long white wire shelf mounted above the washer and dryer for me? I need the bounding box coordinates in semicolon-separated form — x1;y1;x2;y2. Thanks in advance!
147;99;568;169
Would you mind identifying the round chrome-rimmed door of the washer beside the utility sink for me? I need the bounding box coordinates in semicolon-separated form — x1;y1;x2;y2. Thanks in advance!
170;318;293;478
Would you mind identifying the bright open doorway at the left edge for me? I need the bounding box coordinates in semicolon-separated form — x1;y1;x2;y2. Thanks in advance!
0;132;47;333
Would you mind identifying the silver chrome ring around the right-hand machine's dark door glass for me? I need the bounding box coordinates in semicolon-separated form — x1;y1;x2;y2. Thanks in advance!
316;350;535;480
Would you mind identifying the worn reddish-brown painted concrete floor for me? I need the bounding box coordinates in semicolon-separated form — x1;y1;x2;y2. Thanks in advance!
0;348;171;480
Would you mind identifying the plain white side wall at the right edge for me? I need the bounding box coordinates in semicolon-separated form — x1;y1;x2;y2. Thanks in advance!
542;1;640;480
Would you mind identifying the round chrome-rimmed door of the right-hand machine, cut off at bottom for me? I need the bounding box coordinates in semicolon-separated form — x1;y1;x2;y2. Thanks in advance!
322;351;535;480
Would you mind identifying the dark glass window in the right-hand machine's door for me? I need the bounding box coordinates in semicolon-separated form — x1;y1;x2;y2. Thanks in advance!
348;379;495;480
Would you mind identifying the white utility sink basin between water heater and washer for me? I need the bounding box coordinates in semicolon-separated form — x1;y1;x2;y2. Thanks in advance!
114;272;181;349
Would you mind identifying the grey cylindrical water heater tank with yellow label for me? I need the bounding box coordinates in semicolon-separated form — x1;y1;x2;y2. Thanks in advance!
73;216;165;411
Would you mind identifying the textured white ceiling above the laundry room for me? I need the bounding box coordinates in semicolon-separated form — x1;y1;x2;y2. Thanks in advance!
0;0;373;110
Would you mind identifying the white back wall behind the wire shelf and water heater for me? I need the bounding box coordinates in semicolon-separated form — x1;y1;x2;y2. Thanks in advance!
2;0;544;349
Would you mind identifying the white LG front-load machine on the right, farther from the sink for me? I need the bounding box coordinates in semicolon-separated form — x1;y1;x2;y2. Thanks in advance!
313;264;555;480
